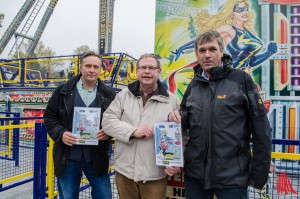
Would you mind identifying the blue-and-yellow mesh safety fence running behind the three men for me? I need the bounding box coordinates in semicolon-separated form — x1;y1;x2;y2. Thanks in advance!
0;112;300;199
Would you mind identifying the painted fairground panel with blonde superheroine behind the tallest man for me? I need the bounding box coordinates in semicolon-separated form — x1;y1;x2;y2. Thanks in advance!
155;0;300;198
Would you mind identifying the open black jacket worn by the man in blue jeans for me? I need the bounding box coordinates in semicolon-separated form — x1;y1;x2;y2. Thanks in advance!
44;75;115;177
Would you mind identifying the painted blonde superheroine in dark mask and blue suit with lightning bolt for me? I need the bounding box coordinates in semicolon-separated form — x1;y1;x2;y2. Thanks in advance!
172;0;277;68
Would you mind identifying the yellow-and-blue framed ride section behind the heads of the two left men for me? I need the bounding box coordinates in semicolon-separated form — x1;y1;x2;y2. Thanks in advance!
0;53;137;88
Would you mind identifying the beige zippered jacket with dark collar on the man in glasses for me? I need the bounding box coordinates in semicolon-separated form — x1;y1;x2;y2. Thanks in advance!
102;81;179;182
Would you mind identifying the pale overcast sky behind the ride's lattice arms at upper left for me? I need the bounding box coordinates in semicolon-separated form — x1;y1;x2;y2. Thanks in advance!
0;0;156;58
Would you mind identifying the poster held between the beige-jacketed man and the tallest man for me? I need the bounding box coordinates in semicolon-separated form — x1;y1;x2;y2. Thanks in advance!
154;122;183;167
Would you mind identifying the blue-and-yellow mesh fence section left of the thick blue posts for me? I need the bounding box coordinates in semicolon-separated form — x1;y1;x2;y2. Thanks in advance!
0;113;35;194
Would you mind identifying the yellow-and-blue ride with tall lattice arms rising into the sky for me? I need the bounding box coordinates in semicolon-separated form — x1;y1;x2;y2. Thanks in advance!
0;0;137;87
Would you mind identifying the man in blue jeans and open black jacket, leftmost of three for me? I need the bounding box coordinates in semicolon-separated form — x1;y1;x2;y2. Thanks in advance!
44;52;115;199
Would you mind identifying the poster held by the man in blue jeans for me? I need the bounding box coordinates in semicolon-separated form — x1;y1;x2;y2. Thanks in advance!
72;107;101;145
